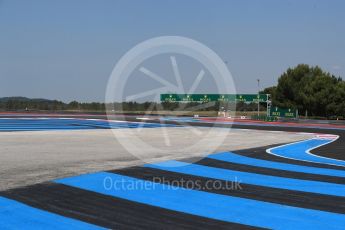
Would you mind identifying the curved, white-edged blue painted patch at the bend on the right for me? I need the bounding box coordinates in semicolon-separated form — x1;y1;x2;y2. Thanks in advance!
268;138;345;166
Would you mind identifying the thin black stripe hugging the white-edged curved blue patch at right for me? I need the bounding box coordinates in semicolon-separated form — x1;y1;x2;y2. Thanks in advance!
231;144;345;171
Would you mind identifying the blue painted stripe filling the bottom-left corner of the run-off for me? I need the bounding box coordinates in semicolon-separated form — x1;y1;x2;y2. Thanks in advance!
0;197;102;229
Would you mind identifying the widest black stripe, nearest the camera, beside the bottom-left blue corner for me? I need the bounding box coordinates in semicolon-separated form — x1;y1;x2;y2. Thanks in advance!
0;183;257;229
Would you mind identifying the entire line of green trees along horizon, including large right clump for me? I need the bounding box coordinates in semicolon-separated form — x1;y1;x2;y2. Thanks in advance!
0;64;345;118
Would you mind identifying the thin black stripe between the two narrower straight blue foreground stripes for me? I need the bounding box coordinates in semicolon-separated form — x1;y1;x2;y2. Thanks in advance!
188;158;345;184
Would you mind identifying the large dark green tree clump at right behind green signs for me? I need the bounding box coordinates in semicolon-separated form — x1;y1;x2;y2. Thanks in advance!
263;64;345;117
